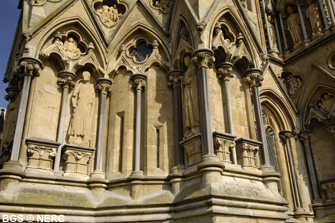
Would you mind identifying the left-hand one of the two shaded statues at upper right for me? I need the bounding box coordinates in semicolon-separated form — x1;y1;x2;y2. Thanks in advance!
287;6;302;47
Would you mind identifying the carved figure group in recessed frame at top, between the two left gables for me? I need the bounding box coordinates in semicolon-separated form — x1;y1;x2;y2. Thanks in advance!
92;0;127;27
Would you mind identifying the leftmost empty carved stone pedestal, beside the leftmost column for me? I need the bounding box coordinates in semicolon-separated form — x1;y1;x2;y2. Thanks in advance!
26;139;60;173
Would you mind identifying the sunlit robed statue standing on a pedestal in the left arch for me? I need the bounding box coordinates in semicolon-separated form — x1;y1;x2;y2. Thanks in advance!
69;71;95;147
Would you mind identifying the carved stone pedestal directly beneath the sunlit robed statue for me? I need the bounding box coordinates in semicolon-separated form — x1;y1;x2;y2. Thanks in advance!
62;144;95;178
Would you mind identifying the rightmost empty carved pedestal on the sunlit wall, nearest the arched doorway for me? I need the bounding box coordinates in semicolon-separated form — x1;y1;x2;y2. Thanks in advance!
235;138;262;170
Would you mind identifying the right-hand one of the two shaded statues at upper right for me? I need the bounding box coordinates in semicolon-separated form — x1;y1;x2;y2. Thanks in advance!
306;0;321;39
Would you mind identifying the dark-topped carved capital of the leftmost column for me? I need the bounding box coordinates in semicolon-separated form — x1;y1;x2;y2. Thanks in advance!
16;57;43;76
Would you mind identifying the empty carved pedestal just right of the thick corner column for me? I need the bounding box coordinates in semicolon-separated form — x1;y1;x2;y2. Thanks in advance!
213;132;236;163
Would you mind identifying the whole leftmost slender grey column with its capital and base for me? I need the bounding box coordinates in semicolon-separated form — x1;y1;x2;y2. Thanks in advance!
3;57;43;171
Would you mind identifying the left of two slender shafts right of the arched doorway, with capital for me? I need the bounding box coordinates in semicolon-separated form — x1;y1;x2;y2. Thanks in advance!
279;130;304;212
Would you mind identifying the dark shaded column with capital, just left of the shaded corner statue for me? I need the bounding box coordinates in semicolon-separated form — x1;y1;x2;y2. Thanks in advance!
168;70;185;166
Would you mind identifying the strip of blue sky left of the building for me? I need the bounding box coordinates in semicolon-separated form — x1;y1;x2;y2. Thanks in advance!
0;0;20;108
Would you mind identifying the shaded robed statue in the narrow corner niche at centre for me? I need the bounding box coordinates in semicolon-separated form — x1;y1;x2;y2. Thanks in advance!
182;56;200;139
